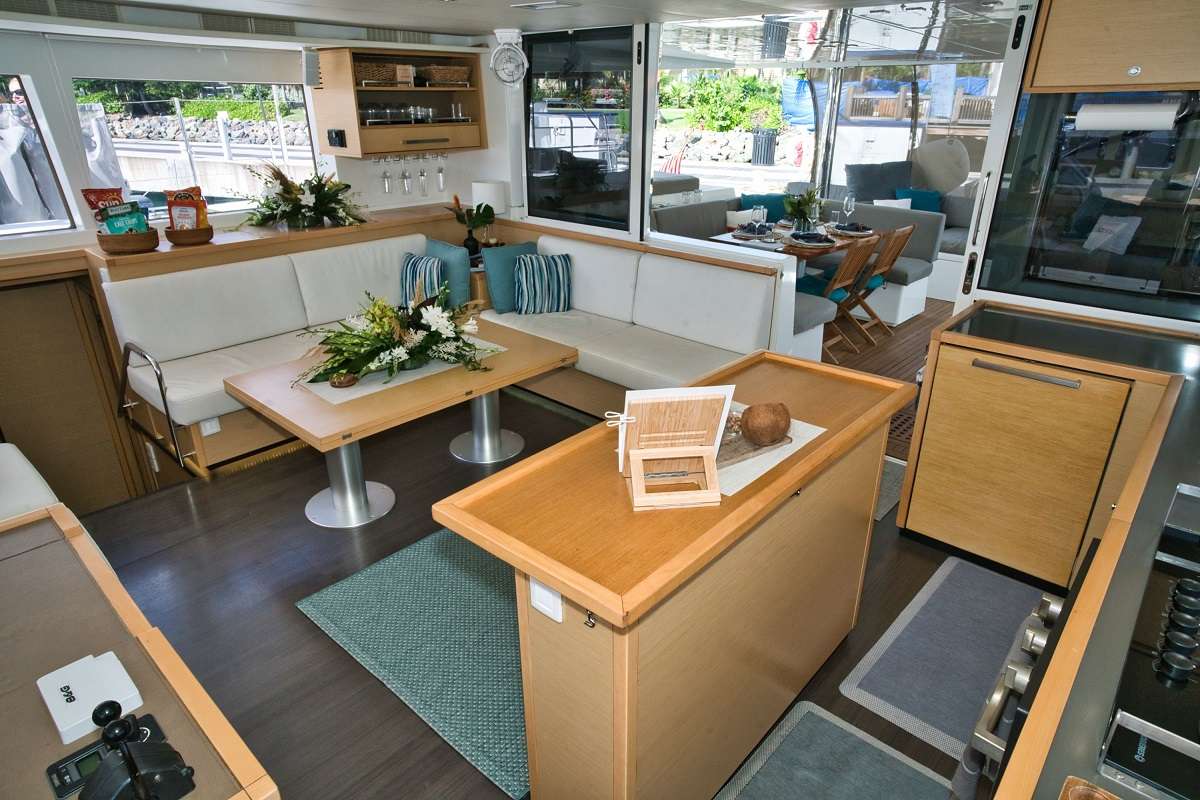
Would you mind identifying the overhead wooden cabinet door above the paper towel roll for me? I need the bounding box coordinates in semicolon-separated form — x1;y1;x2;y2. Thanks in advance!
1027;0;1200;91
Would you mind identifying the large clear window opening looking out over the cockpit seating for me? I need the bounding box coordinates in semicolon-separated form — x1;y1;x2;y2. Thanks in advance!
649;2;1014;237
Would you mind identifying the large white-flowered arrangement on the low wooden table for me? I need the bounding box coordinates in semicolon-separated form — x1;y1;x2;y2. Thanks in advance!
295;284;490;387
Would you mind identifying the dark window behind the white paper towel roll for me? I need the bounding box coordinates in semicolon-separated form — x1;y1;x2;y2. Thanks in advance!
979;91;1200;320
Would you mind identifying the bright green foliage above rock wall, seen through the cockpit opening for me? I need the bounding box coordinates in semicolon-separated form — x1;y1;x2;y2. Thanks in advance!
662;73;784;131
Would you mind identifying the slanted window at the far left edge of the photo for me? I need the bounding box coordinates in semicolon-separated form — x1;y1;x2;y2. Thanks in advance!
0;74;73;236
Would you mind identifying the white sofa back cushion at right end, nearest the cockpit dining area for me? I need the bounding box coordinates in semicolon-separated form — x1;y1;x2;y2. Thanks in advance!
634;253;775;353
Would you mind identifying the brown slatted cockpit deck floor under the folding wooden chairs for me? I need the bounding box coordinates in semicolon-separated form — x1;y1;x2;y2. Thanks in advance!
824;299;954;461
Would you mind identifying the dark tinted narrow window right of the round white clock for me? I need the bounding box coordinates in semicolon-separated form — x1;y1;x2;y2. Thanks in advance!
523;28;634;230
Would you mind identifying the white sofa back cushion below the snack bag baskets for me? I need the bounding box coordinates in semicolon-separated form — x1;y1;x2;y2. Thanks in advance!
104;255;307;361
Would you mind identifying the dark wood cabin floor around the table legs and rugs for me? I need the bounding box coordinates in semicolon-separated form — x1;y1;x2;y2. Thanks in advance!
84;396;953;800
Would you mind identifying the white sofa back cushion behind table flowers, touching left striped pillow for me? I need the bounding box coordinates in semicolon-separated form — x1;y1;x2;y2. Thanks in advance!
292;234;425;325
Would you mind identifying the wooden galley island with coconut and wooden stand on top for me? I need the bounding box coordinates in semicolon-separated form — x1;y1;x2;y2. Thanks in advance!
433;353;916;800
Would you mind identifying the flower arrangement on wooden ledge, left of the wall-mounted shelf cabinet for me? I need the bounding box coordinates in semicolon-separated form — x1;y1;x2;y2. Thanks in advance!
238;164;366;230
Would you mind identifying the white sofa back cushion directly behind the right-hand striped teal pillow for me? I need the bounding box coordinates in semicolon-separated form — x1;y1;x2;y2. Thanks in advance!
538;236;642;323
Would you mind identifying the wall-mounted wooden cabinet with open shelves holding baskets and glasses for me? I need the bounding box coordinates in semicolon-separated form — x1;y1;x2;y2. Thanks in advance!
312;48;487;158
